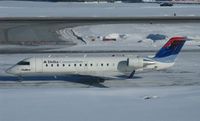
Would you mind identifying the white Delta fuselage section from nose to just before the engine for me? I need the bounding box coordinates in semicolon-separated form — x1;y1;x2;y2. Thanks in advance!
9;57;131;75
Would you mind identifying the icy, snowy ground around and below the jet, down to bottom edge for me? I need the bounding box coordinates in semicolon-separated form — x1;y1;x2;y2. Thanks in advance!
0;52;200;121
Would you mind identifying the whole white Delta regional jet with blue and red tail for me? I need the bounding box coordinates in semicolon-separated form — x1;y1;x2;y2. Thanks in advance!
6;37;187;78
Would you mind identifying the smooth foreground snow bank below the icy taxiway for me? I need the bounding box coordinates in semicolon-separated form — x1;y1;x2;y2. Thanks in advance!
0;86;200;121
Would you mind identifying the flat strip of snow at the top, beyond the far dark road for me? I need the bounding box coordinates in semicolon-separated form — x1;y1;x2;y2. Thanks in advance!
0;1;200;17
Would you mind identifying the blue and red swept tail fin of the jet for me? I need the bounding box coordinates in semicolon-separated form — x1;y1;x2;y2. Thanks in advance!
154;37;187;63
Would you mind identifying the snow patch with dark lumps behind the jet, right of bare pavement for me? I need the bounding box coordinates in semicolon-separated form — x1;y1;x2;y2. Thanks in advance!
54;23;200;51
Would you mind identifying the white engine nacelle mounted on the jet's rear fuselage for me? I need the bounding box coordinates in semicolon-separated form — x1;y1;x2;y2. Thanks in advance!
127;57;144;69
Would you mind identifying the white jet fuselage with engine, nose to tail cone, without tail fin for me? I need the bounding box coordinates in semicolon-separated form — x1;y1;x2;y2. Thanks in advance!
7;57;173;76
